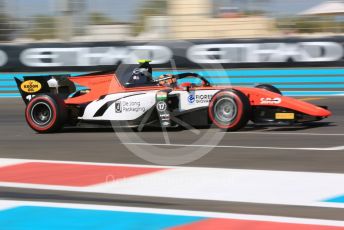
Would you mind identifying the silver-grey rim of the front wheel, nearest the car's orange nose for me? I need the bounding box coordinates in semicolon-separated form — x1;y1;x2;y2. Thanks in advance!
214;98;238;124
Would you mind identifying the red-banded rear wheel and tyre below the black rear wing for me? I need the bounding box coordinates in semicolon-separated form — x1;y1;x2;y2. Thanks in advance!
25;95;67;133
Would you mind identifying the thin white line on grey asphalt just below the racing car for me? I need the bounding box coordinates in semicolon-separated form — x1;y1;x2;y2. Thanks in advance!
123;142;344;151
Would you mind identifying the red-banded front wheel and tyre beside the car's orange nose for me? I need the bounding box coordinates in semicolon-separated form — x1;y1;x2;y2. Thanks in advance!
208;90;251;131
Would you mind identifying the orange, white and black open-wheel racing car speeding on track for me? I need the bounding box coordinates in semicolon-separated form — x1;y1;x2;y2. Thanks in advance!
15;60;331;133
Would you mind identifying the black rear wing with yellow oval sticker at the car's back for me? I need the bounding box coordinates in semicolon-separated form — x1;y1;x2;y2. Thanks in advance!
14;75;76;104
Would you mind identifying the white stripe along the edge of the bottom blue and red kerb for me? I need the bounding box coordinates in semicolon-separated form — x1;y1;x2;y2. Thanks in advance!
0;200;344;227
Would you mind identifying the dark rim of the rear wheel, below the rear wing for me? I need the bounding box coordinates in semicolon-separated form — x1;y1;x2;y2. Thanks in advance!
31;102;52;126
